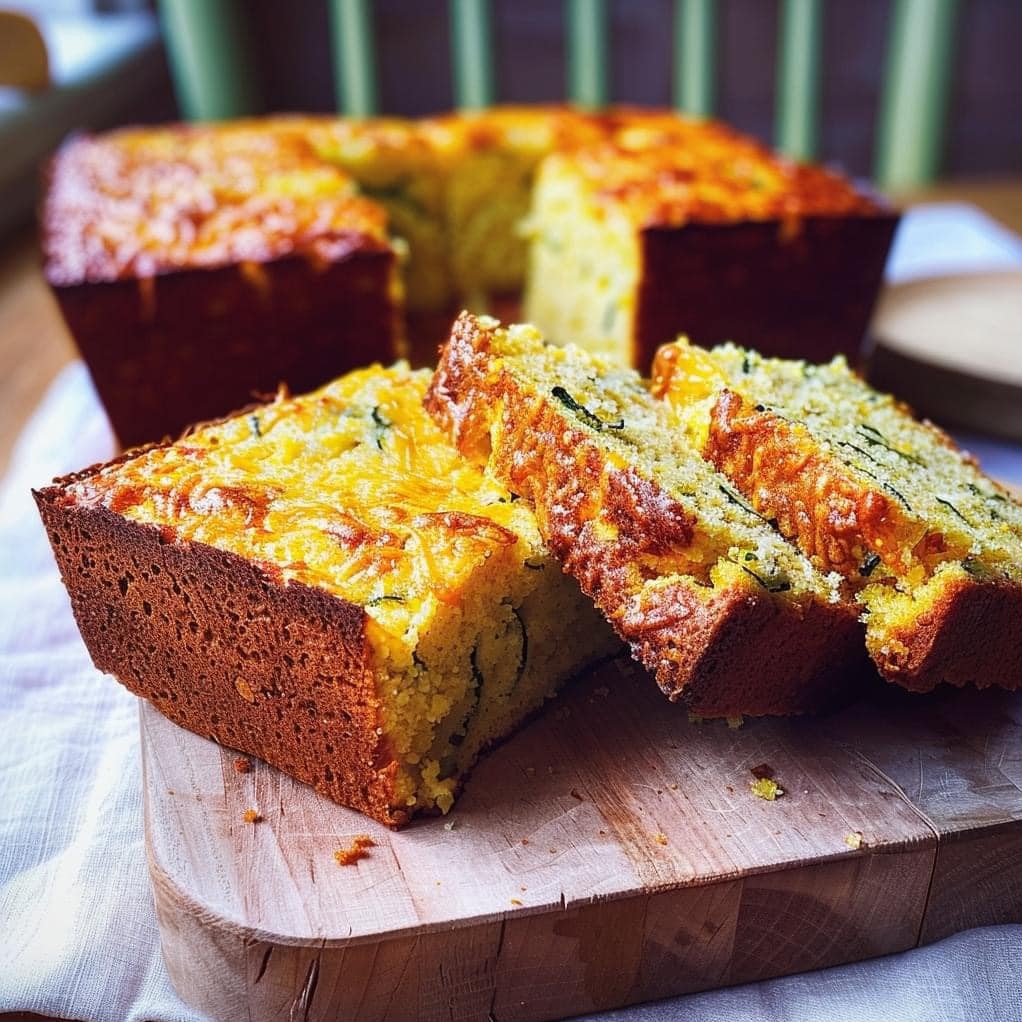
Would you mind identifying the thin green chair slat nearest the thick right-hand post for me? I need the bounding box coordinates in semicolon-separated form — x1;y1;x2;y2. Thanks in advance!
775;0;824;159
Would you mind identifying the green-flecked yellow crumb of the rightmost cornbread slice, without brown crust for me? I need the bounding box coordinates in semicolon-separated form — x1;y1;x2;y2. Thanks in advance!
665;339;1022;654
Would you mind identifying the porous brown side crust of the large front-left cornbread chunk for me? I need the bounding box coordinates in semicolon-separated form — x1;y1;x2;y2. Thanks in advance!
34;485;410;826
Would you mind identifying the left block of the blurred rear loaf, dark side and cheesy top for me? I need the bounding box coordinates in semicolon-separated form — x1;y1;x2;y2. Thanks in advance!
43;120;401;446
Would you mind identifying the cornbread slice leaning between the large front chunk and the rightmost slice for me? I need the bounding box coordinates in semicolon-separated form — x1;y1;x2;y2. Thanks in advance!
427;314;865;716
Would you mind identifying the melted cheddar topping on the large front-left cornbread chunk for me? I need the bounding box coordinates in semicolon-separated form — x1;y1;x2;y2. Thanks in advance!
63;364;542;636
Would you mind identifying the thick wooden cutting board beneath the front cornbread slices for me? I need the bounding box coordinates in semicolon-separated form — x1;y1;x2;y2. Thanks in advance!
142;661;1022;1022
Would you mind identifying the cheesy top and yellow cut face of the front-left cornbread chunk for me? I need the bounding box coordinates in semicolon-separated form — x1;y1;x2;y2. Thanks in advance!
68;364;617;811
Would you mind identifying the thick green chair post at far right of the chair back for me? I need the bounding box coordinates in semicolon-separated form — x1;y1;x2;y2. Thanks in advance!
874;0;958;189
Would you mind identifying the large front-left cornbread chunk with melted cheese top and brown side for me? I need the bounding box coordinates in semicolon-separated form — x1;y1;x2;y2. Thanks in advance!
36;365;619;825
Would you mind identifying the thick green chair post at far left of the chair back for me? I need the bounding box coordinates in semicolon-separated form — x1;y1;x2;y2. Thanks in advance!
159;0;261;121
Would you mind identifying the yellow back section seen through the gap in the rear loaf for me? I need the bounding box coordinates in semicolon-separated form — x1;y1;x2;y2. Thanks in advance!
310;107;589;312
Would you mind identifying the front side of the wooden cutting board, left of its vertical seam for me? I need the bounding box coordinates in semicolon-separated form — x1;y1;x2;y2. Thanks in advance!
148;829;933;1022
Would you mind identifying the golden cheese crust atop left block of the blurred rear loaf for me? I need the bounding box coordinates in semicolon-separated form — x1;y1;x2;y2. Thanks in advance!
43;119;389;286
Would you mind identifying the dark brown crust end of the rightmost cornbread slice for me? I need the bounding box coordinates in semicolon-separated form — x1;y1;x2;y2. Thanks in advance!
873;578;1022;692
